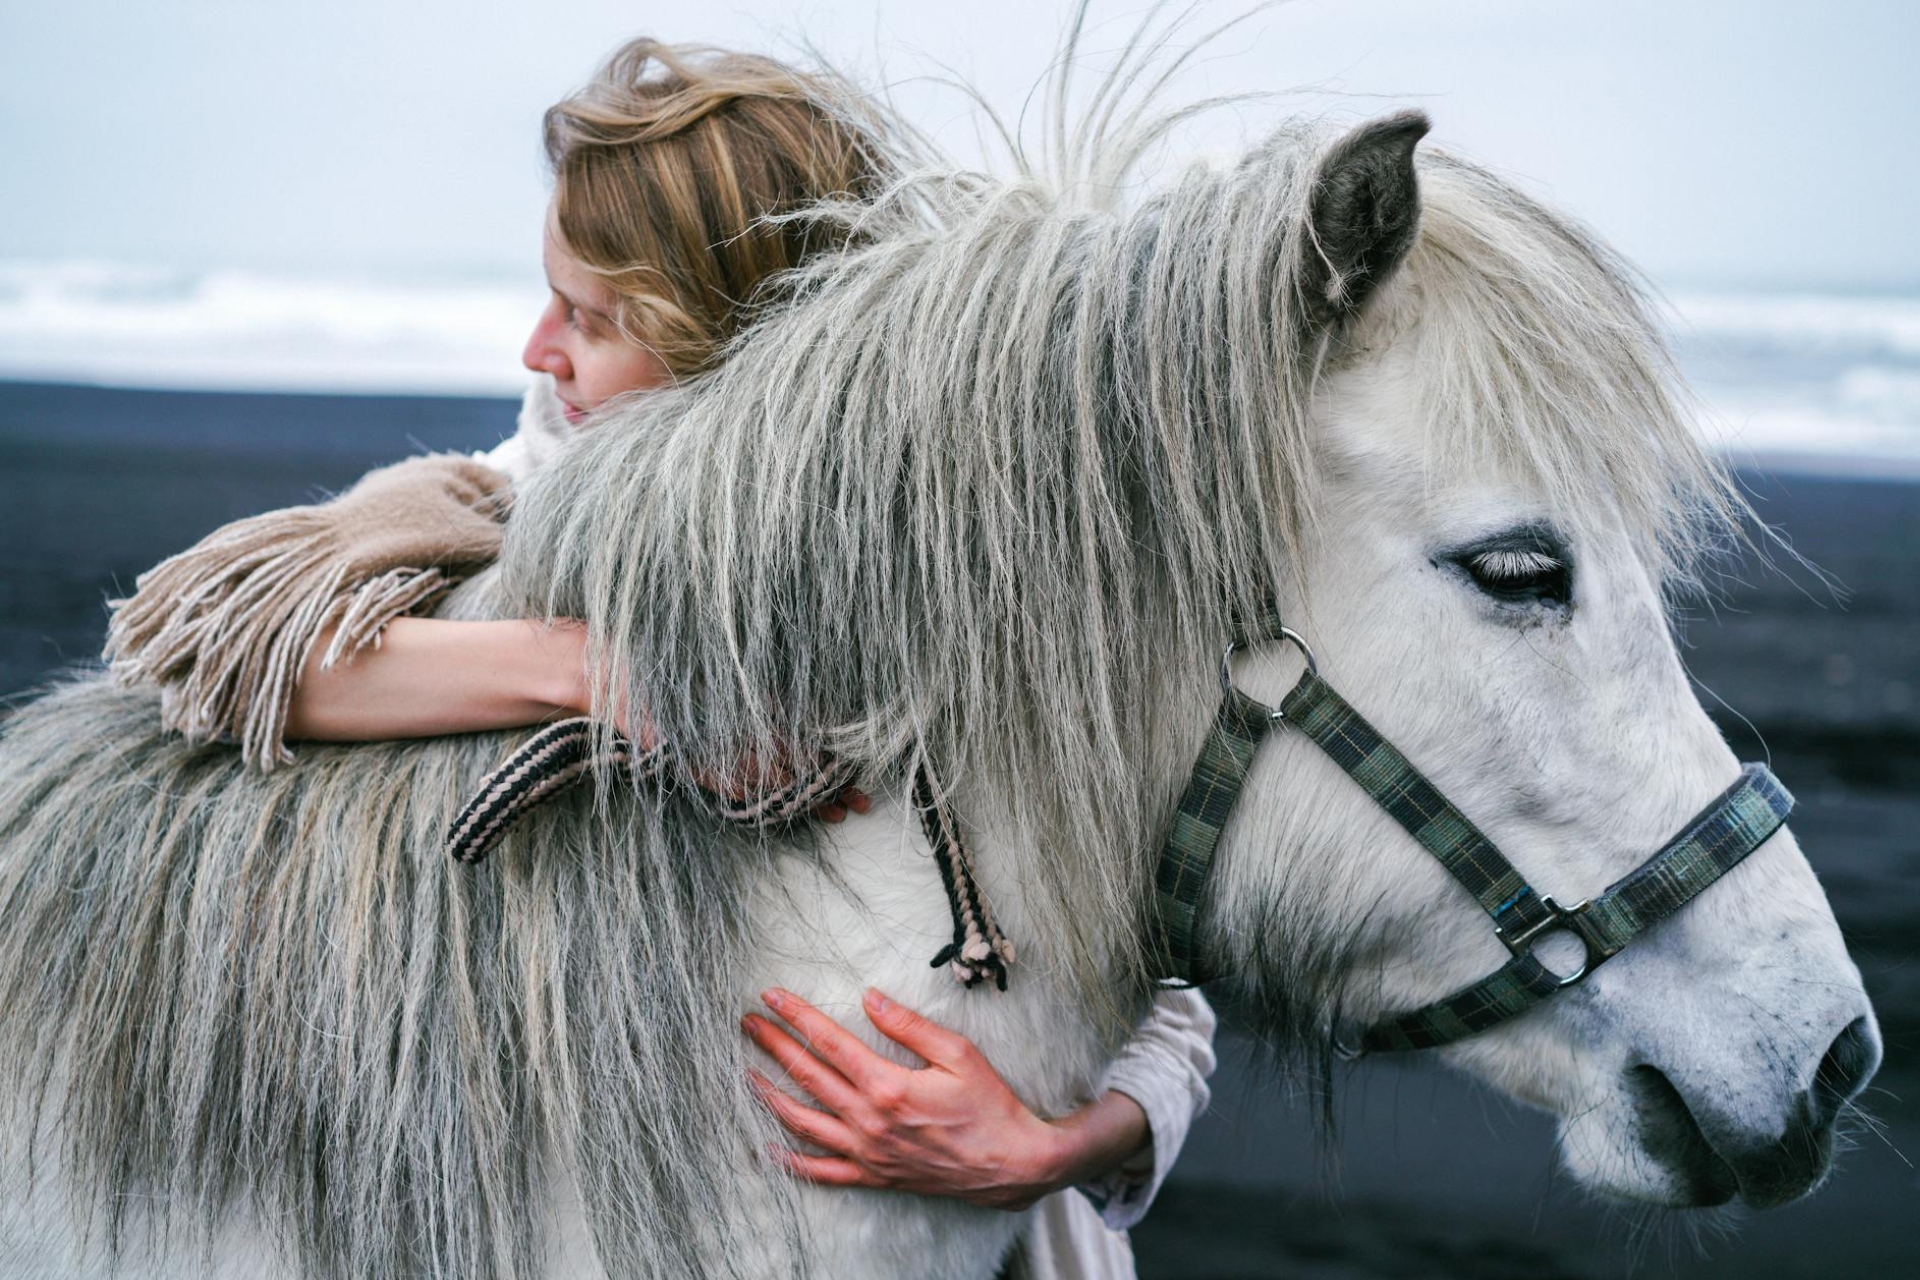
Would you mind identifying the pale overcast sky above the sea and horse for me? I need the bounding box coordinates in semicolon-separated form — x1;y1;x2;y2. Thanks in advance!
0;0;1920;288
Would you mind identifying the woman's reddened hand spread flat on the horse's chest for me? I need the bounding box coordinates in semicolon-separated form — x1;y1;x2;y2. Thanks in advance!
741;990;1150;1209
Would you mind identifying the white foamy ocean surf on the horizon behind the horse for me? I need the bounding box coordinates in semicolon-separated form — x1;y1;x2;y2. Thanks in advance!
0;261;1920;476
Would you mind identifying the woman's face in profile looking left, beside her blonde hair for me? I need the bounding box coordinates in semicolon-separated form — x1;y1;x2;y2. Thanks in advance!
520;209;674;422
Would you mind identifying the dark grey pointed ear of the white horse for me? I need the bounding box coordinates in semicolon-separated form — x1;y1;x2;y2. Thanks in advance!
1300;111;1430;324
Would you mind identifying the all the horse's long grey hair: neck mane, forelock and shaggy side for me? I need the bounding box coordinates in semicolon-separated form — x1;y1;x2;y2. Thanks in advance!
0;20;1732;1276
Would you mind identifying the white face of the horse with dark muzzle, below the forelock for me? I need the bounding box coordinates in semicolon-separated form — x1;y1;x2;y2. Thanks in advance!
1219;112;1880;1207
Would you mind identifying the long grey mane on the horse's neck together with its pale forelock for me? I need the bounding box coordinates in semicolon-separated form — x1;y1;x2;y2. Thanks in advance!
503;92;1740;1027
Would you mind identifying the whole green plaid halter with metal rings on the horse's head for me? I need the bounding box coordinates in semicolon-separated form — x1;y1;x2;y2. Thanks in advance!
1154;608;1793;1057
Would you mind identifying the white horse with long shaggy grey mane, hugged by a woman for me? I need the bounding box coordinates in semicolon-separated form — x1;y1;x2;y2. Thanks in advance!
0;84;1880;1280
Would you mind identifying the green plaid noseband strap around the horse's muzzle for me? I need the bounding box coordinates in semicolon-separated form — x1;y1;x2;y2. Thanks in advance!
1357;764;1793;1054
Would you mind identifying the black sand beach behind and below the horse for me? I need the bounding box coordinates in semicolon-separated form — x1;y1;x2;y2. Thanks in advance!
0;382;1920;1280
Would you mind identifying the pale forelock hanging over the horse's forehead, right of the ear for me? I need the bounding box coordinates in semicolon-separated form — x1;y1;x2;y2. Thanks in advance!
1402;152;1751;591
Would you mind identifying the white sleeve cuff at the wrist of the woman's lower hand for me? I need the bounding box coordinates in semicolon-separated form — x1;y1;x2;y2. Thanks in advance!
1079;990;1215;1230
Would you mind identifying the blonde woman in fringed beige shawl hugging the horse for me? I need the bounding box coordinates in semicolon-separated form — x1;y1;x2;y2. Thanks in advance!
108;40;1213;1276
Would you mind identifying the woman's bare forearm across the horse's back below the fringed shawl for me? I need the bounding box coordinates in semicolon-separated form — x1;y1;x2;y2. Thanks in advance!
286;618;599;748
